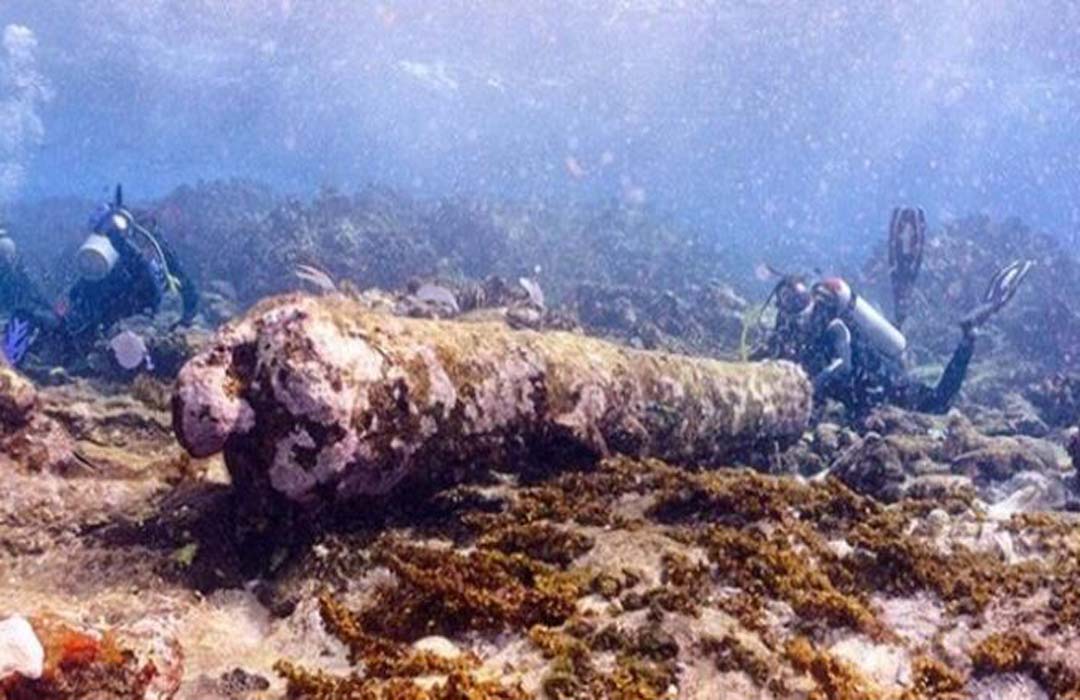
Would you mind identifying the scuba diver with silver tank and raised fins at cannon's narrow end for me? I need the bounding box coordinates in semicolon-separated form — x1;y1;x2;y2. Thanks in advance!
751;208;1032;416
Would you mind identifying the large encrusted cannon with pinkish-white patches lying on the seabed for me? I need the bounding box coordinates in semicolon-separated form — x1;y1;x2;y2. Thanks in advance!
173;295;811;503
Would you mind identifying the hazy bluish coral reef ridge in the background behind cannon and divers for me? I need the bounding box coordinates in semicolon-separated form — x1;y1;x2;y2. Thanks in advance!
11;180;1080;405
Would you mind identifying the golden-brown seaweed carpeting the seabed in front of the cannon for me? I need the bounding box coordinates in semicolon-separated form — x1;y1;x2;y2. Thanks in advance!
261;459;1078;700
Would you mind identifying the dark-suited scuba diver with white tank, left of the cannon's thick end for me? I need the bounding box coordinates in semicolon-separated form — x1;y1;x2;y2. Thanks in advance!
3;185;199;365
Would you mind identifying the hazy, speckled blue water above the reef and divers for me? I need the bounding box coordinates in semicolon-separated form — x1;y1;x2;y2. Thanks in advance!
0;0;1080;258
